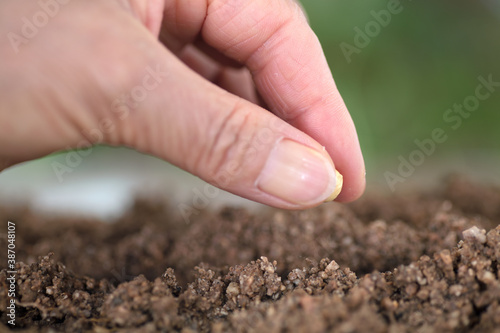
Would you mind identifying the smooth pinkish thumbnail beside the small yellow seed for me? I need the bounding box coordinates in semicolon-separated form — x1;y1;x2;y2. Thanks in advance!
256;139;342;205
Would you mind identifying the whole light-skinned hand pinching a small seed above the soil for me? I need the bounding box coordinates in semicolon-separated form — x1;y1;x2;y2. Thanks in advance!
0;0;365;209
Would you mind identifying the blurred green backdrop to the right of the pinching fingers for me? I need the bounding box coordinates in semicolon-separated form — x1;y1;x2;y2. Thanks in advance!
302;0;500;182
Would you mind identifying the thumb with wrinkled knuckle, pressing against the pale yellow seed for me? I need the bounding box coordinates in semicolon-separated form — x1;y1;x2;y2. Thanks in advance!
115;50;342;209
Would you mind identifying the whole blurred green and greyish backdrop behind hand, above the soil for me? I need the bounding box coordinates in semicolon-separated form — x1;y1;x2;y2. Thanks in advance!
0;0;500;218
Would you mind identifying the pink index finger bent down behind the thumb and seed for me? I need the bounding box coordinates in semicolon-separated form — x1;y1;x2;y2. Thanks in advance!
164;0;365;201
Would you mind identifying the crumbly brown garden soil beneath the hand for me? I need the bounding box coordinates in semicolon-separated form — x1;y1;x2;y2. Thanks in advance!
0;177;500;333
